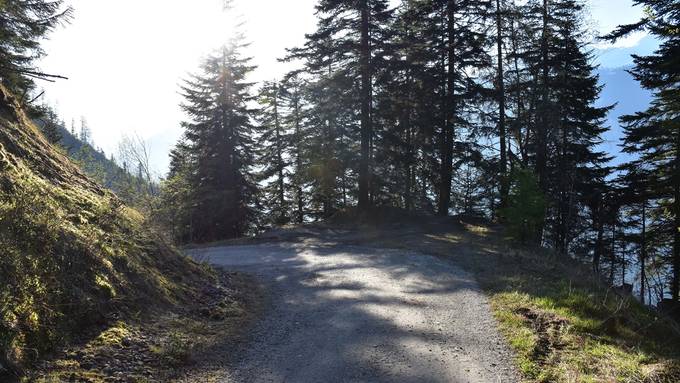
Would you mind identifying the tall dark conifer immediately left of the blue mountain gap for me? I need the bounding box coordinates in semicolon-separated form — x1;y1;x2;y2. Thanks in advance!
544;0;611;254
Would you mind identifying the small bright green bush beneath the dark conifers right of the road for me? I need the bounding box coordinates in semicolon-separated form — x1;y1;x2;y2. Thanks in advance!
501;168;546;244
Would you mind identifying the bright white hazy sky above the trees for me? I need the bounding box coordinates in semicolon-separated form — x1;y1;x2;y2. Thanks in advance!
39;0;644;173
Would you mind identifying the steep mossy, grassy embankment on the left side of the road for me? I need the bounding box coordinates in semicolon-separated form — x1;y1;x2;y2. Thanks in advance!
0;86;215;375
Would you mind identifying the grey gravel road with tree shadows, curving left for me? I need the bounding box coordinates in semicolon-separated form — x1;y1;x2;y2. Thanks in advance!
186;236;518;383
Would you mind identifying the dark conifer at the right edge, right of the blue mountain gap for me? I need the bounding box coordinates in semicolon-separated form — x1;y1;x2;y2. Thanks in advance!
605;0;680;301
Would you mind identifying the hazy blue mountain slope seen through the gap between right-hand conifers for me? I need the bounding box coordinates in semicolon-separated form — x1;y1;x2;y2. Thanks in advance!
598;67;652;164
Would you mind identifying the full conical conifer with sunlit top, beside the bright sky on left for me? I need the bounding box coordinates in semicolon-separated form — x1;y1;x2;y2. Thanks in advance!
177;40;257;241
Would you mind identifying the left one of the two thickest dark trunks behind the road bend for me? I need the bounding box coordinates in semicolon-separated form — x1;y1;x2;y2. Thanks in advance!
359;0;373;208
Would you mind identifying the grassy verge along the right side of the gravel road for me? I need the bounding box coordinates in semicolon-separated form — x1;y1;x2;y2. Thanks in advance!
338;212;680;383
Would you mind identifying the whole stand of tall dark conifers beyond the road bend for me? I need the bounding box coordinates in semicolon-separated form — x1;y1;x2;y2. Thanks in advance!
0;0;680;303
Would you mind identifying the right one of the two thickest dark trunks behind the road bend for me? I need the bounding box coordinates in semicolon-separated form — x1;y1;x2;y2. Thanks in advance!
438;0;456;216
